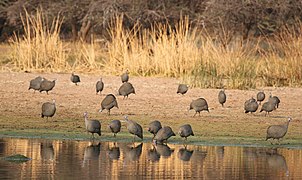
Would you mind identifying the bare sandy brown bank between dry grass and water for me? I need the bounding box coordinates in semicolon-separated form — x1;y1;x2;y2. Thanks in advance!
0;72;302;146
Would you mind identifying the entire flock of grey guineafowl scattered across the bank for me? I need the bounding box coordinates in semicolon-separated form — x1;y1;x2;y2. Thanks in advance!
28;70;292;144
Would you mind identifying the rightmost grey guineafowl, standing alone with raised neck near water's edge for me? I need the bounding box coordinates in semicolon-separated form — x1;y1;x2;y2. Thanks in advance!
265;117;292;144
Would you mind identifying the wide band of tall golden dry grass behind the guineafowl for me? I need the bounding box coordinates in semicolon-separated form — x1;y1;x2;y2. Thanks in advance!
4;11;302;89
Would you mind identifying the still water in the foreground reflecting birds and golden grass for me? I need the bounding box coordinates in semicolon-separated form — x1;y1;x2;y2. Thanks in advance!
0;138;302;180
